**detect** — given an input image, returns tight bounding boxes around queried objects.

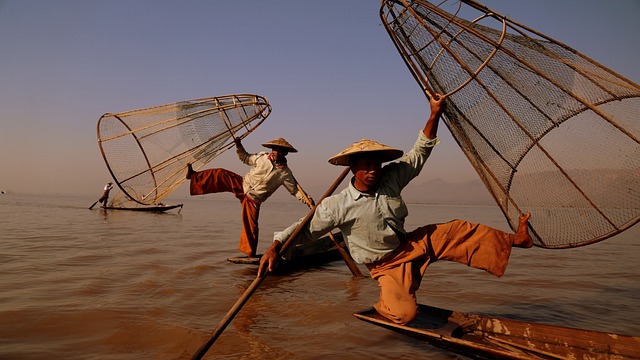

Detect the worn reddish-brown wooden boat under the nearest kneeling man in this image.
[354,305,640,360]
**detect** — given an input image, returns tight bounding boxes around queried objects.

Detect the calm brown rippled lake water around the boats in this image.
[0,194,640,359]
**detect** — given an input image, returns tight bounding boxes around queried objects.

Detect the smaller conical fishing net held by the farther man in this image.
[98,94,271,205]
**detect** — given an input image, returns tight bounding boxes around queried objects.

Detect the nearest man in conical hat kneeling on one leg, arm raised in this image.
[258,95,533,324]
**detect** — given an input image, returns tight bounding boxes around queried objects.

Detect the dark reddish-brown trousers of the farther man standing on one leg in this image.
[189,169,260,256]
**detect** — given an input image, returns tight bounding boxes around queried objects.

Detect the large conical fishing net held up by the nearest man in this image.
[380,0,640,248]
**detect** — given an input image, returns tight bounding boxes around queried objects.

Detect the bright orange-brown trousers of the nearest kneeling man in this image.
[367,220,513,324]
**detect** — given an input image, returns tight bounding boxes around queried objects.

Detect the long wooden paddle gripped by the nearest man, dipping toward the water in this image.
[191,167,349,360]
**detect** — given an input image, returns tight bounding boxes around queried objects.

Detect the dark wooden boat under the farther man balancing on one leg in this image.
[227,233,346,273]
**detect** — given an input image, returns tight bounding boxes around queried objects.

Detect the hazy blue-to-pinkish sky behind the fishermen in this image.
[0,0,640,196]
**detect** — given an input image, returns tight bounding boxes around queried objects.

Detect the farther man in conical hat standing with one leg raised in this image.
[187,138,313,257]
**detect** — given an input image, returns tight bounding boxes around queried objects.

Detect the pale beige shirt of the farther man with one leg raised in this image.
[236,146,309,205]
